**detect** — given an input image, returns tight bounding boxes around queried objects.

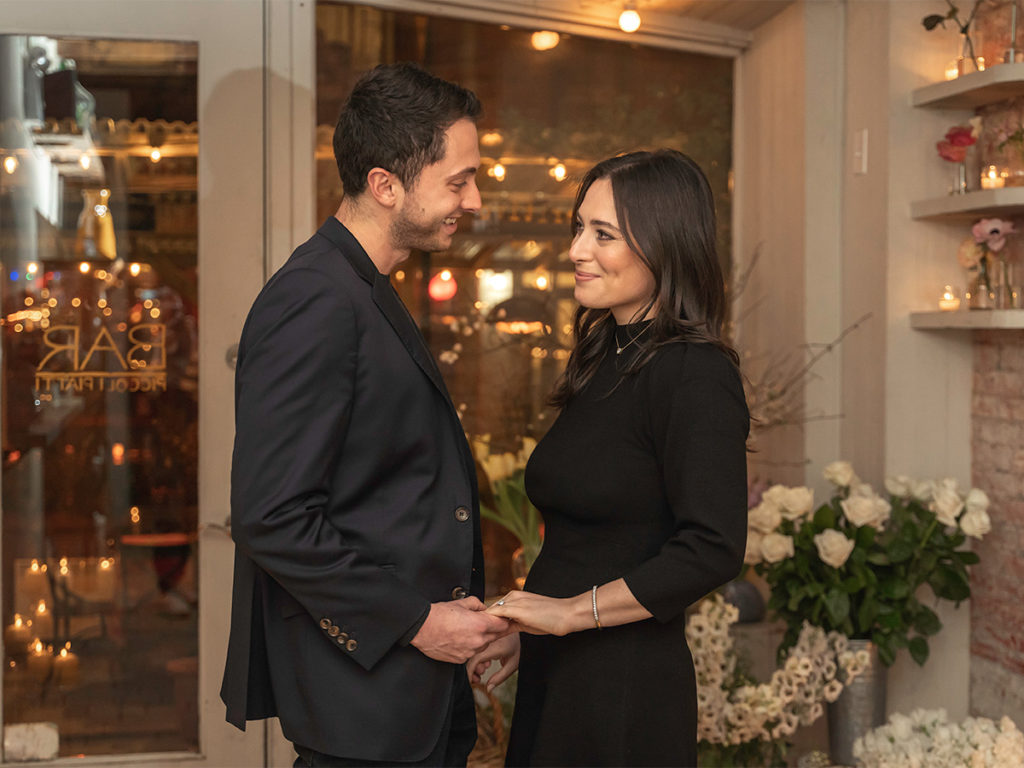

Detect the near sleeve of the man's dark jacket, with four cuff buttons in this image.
[231,268,429,669]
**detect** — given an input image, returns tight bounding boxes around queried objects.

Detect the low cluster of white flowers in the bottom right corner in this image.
[853,710,1024,768]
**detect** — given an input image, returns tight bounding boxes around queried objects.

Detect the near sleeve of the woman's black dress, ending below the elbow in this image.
[626,344,750,622]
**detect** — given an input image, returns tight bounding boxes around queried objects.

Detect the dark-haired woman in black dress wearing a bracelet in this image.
[470,150,750,766]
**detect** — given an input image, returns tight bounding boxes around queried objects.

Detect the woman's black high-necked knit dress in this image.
[506,324,750,766]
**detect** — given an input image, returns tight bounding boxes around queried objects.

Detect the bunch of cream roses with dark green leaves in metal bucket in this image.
[743,461,992,667]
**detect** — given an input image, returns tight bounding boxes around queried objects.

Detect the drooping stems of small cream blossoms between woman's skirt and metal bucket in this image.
[686,595,870,765]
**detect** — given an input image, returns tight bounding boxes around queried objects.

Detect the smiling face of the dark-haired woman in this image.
[569,178,654,325]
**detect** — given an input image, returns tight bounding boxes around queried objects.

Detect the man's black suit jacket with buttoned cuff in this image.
[221,218,483,761]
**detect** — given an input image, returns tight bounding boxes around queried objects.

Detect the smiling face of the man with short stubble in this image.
[391,119,480,252]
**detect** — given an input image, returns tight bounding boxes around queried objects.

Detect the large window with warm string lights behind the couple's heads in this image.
[316,2,732,594]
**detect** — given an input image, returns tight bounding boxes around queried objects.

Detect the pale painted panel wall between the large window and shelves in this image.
[735,0,971,719]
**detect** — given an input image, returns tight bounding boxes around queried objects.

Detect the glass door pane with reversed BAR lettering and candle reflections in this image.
[0,36,199,762]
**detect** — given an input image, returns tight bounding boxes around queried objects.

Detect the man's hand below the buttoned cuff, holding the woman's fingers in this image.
[412,597,511,664]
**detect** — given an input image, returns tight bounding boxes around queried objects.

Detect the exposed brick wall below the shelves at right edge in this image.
[971,331,1024,723]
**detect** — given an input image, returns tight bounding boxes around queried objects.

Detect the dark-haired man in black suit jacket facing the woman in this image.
[221,65,508,766]
